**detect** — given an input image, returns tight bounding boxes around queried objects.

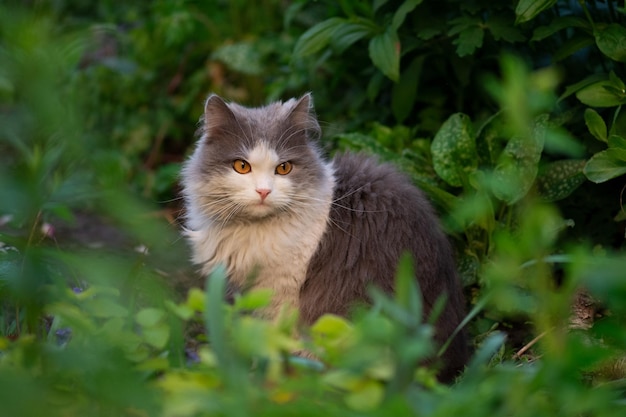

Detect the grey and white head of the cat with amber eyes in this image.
[183,95,332,227]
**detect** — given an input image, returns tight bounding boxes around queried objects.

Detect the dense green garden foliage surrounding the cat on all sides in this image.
[0,0,626,416]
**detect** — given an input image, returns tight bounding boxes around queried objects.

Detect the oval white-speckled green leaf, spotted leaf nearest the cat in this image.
[431,113,478,187]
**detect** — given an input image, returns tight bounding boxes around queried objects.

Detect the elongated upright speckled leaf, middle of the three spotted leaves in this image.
[494,115,548,204]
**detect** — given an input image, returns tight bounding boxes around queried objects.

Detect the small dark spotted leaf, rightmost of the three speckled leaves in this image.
[537,159,586,201]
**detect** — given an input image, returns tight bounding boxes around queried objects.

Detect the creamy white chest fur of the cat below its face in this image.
[187,197,331,316]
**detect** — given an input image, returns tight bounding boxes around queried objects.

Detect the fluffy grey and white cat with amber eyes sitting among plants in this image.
[181,94,468,380]
